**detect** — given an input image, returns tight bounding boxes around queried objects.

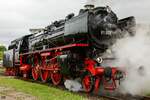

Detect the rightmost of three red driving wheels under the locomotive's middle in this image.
[51,72,62,85]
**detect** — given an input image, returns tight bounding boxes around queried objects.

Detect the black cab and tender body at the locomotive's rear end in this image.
[3,35,29,67]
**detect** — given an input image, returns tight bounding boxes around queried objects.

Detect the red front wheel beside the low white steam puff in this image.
[82,72,95,93]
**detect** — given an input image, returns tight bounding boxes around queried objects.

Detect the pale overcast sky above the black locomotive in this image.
[0,0,150,46]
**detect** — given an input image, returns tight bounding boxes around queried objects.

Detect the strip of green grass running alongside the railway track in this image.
[0,76,86,100]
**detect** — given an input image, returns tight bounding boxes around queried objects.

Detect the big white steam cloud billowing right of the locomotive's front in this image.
[111,26,150,95]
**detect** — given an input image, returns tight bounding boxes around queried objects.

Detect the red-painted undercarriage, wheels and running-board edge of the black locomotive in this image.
[5,44,122,92]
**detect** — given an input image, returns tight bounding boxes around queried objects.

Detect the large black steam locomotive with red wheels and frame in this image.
[3,5,135,92]
